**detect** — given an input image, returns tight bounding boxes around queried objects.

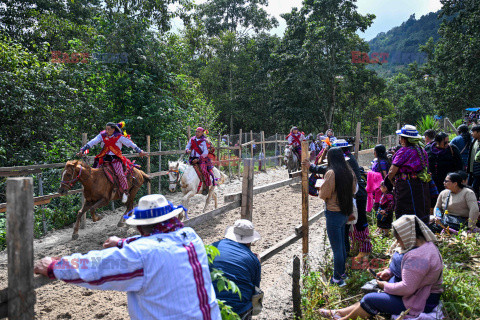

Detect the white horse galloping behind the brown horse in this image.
[168,161,227,212]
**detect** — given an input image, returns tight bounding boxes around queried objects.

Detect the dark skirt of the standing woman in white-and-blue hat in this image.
[394,178,430,223]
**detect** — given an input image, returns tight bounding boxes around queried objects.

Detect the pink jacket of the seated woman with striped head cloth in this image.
[384,242,443,318]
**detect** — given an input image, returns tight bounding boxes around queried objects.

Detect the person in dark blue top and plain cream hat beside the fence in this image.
[210,219,261,320]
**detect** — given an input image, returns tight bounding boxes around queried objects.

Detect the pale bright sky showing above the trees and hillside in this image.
[266,0,442,40]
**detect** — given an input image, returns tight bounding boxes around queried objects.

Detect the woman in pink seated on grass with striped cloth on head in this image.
[319,215,443,320]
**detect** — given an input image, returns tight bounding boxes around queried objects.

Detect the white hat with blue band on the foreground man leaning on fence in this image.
[125,194,187,226]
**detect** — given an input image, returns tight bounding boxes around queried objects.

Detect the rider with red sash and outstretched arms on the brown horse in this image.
[77,121,147,203]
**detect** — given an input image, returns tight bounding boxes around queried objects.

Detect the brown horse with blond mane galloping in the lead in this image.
[58,160,150,240]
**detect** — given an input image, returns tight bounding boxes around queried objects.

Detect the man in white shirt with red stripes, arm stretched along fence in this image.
[35,194,221,320]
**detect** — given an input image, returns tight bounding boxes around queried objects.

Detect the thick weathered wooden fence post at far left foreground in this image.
[7,178,36,320]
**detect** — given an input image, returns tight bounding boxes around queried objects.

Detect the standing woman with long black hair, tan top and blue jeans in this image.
[302,148,357,287]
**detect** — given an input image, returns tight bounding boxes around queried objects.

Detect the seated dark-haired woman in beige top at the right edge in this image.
[435,172,479,231]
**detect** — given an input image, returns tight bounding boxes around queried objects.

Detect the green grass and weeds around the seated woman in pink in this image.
[302,211,480,320]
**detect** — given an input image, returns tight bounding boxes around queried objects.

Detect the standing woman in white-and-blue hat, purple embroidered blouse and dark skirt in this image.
[388,125,430,223]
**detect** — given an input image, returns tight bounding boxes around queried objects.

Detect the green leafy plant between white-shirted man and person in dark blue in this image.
[205,245,242,320]
